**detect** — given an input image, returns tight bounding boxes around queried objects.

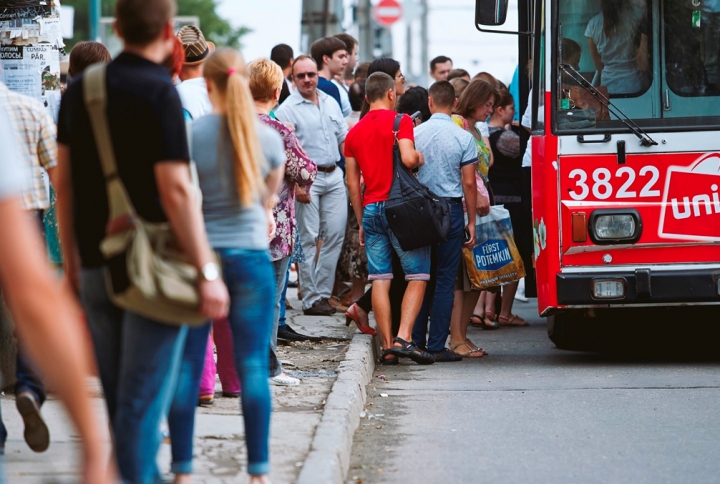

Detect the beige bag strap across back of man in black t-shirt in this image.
[82,63,135,220]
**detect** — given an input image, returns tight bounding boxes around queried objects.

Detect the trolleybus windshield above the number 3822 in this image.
[553,0,720,133]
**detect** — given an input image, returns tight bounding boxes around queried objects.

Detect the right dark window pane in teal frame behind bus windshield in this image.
[664,0,720,99]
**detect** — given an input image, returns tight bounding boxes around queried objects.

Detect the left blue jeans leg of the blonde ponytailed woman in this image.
[168,322,210,474]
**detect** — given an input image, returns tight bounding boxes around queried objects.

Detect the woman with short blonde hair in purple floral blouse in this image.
[248,59,317,386]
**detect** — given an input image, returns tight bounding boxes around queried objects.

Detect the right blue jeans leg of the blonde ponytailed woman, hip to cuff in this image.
[216,249,275,475]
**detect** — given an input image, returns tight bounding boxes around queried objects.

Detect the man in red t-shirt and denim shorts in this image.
[345,72,435,365]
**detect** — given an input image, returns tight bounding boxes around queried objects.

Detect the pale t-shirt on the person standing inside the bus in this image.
[585,8,647,94]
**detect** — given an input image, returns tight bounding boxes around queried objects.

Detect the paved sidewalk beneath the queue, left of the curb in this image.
[0,289,355,484]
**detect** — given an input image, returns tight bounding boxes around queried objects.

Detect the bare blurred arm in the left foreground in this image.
[0,198,111,484]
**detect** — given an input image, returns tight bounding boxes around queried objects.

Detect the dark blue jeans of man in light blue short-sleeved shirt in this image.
[412,200,465,351]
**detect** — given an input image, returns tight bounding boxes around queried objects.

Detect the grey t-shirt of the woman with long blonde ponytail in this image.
[192,114,285,250]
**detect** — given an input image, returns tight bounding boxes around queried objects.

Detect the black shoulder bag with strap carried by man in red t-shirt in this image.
[385,114,450,250]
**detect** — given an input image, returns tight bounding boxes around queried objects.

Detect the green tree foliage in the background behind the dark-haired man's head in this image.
[61,0,252,52]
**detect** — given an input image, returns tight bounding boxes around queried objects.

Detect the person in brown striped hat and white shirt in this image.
[177,25,215,120]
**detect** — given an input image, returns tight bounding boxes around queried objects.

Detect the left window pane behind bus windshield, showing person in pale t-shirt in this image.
[557,0,652,97]
